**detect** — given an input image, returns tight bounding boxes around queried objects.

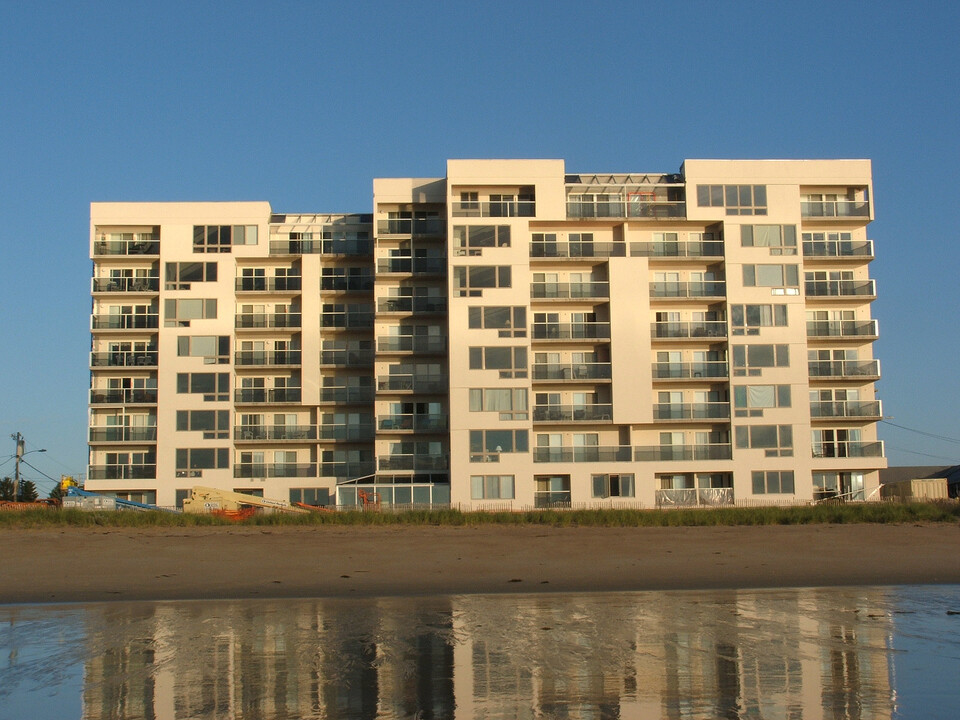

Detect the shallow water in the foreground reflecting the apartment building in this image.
[0,586,960,720]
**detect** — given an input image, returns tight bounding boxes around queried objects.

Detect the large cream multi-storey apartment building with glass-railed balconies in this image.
[86,160,886,509]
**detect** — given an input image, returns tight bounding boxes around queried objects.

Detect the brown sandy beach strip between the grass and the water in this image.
[0,524,960,603]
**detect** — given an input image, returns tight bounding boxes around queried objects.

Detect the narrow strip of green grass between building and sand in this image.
[0,501,960,530]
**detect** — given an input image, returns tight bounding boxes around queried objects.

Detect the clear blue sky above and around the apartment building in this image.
[0,0,960,487]
